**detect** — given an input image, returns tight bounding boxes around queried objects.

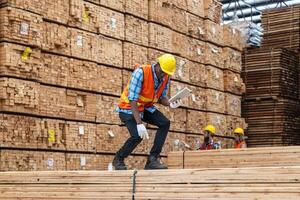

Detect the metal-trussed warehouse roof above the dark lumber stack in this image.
[221,0,300,24]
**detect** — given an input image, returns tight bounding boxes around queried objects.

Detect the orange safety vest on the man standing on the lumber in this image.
[119,65,169,112]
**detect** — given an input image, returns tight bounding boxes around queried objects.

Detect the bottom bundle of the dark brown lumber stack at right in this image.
[242,98,300,146]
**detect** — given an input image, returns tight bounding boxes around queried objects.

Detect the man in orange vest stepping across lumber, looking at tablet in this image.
[112,54,181,170]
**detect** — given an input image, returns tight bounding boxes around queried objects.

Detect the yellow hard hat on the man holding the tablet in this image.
[157,54,176,76]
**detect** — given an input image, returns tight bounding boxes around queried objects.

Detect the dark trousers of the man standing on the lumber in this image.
[116,110,170,158]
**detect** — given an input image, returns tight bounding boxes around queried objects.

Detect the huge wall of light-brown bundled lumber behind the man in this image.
[0,0,245,170]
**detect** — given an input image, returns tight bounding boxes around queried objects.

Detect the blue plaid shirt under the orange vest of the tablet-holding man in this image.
[117,65,170,114]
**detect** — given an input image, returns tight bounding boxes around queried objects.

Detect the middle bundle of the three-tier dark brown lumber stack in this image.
[242,49,299,100]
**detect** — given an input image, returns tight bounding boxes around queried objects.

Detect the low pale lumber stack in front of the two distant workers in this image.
[168,146,300,169]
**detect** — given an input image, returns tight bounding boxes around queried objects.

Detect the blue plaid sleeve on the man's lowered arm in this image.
[128,68,144,101]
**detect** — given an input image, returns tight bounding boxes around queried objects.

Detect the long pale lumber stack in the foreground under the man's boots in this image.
[0,166,300,200]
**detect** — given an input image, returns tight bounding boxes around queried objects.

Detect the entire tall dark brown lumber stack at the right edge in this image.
[242,5,300,147]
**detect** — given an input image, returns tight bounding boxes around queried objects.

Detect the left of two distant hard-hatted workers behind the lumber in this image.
[199,124,220,150]
